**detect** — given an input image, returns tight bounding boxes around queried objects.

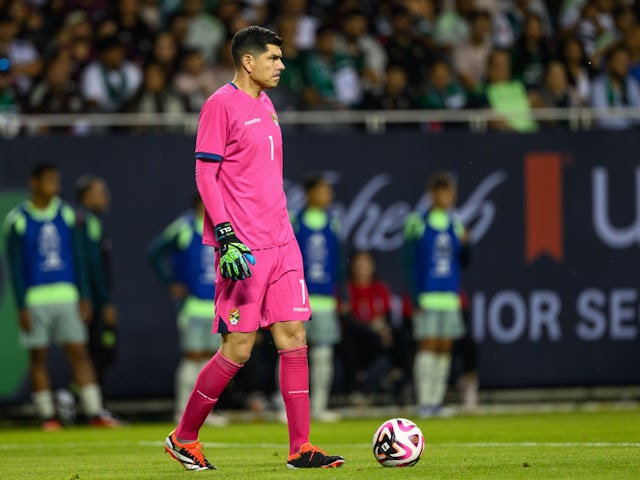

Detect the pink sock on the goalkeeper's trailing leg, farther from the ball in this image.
[176,350,242,441]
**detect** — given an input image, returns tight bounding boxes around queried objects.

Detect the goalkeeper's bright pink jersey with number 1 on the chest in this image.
[196,83,295,249]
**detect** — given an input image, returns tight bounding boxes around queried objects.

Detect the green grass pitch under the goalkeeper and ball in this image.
[0,410,640,480]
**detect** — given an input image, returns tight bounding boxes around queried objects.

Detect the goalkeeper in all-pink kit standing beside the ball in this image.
[165,26,344,470]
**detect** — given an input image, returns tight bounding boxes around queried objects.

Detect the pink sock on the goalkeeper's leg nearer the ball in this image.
[278,346,310,455]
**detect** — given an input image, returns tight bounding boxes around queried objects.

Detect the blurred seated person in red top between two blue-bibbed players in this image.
[343,251,393,401]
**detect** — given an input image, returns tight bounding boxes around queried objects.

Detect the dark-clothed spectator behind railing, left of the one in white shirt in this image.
[28,52,86,133]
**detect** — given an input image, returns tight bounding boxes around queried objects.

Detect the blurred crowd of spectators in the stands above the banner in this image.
[0,0,640,132]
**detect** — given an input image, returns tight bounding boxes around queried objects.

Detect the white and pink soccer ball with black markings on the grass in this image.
[373,418,424,467]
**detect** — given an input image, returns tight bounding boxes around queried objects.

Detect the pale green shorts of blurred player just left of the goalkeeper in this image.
[178,297,222,353]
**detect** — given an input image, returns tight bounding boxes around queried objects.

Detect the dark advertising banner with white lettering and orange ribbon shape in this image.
[0,130,640,399]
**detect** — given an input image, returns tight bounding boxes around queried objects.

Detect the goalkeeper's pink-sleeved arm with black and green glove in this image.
[196,101,256,280]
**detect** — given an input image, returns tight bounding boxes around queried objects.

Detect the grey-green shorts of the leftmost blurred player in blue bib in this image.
[20,302,87,349]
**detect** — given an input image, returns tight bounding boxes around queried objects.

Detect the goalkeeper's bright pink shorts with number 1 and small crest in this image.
[212,239,311,333]
